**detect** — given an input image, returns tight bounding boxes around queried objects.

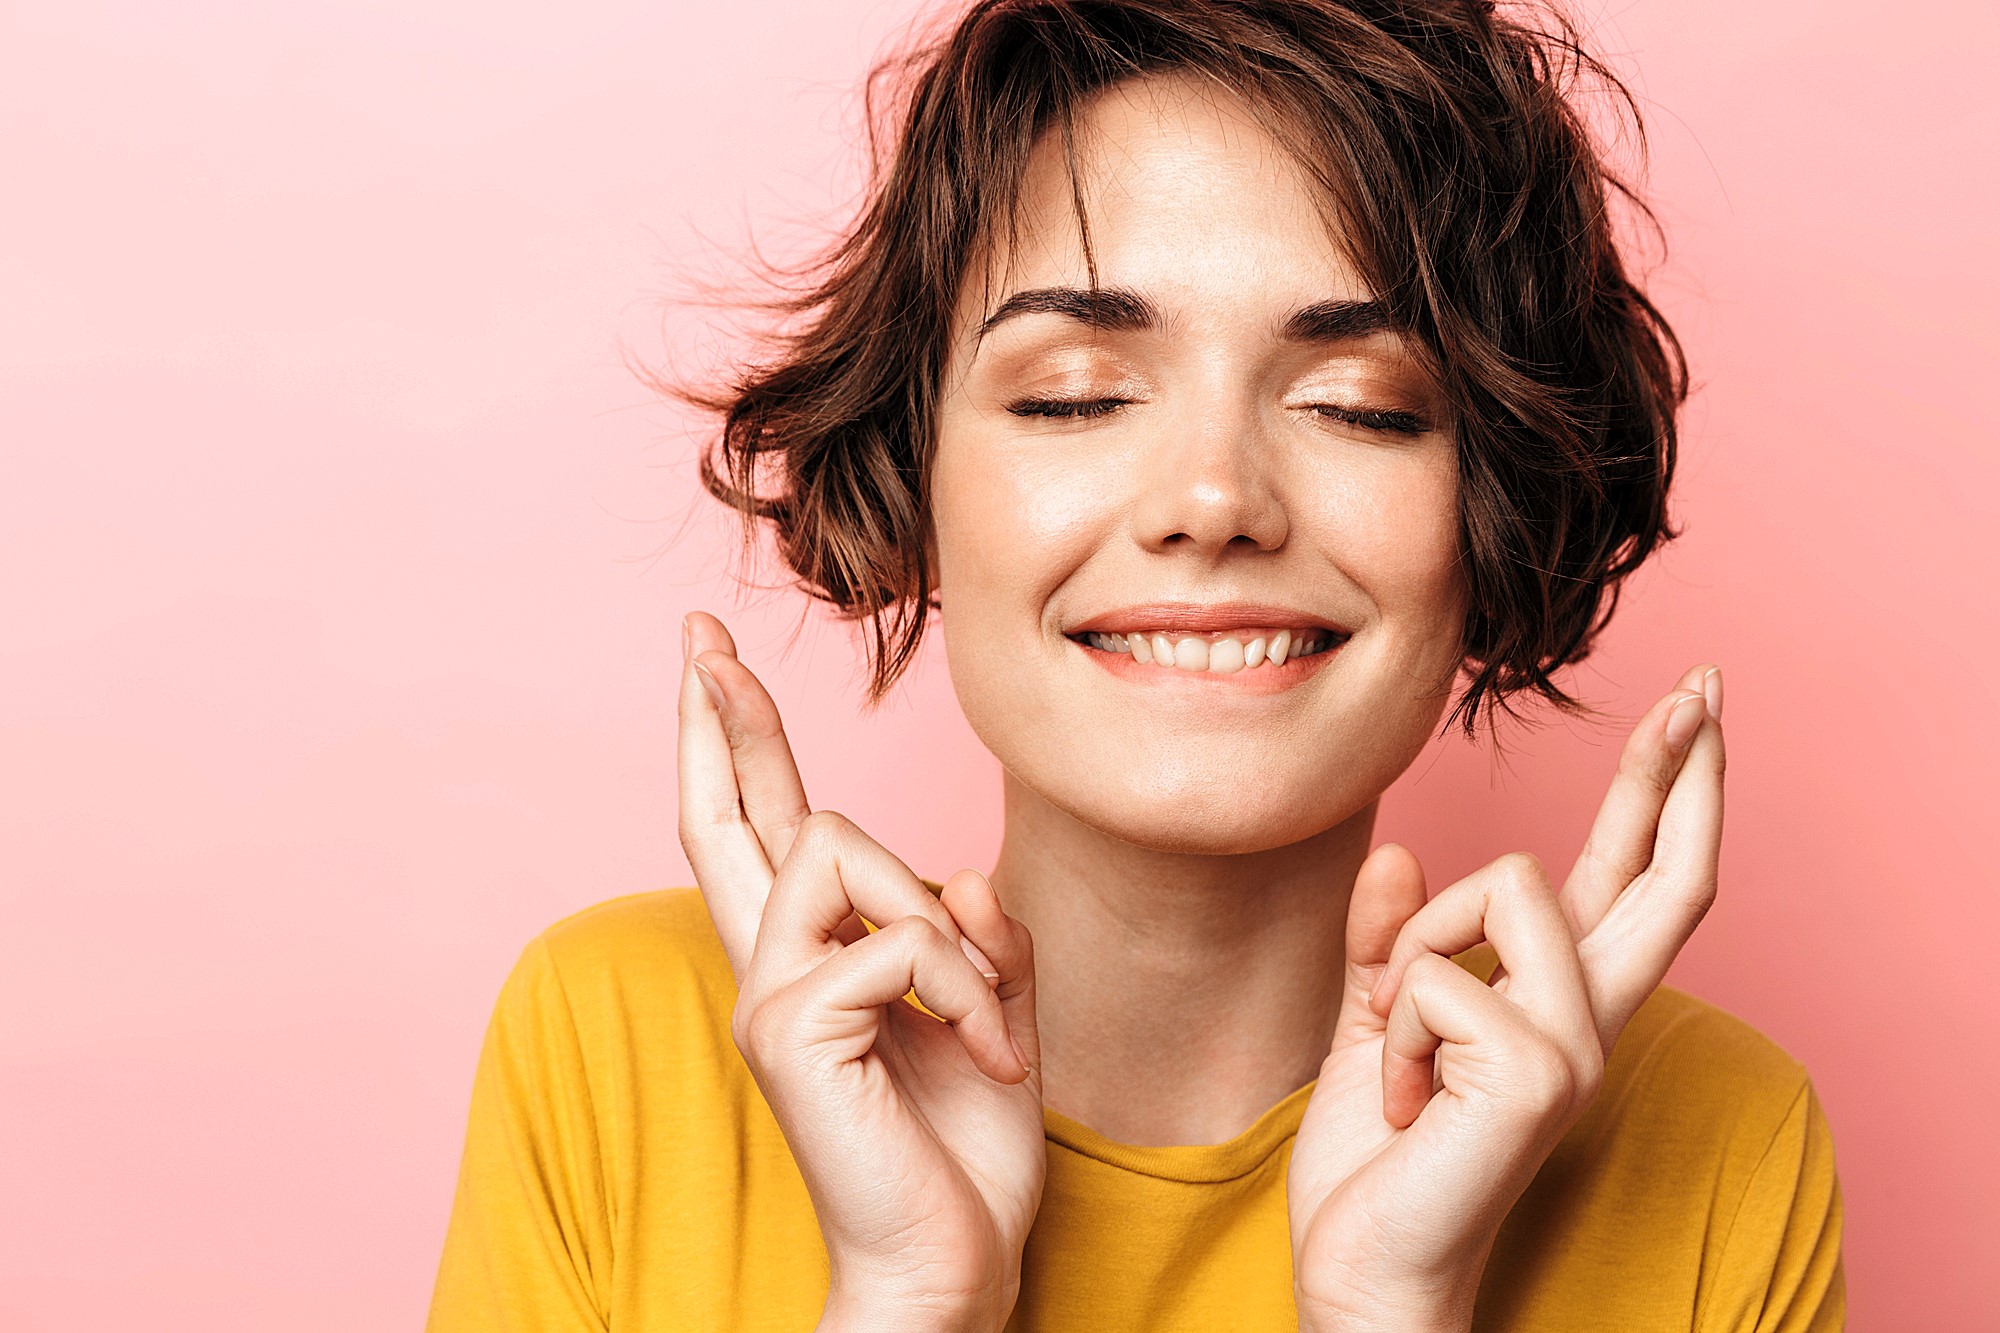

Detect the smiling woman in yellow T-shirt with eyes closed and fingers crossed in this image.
[432,0,1844,1331]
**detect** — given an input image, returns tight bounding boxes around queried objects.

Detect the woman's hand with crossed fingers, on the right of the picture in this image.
[1286,664,1724,1333]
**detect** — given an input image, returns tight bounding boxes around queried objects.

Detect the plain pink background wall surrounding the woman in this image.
[0,0,2000,1333]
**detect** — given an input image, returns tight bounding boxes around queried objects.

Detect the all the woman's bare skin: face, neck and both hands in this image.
[680,78,1724,1333]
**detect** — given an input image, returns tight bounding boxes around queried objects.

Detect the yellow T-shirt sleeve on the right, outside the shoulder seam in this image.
[1700,1079,1848,1333]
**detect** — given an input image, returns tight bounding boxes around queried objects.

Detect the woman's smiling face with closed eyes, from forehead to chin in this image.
[932,76,1466,853]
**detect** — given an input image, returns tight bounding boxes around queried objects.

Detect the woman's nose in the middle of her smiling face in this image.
[1134,392,1290,554]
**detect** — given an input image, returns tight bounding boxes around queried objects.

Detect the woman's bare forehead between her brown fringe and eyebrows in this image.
[956,74,1372,332]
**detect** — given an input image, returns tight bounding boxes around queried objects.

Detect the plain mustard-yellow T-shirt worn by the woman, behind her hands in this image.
[430,887,1846,1333]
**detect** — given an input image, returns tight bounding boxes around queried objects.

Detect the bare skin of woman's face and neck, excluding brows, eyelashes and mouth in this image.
[932,80,1466,1143]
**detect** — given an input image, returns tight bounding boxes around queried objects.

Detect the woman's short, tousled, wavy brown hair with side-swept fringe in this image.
[662,0,1688,737]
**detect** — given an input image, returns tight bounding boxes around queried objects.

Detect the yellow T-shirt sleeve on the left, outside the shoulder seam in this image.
[426,939,610,1333]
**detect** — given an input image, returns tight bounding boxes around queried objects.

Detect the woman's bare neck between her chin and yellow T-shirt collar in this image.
[992,775,1376,1145]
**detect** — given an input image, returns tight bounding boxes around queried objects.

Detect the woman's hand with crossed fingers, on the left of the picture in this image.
[680,612,1046,1329]
